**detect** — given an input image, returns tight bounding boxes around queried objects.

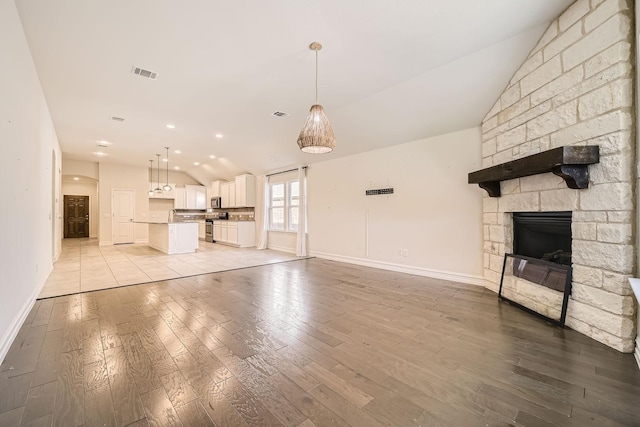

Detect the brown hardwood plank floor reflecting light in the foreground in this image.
[0,259,640,427]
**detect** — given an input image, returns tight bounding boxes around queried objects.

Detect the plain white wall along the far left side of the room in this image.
[0,0,62,360]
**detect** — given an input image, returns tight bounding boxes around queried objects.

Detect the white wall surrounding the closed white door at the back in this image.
[98,163,149,245]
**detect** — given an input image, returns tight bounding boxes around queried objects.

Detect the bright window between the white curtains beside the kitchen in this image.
[269,180,300,232]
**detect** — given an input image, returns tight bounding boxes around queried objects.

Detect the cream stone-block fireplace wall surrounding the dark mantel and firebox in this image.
[479,0,636,352]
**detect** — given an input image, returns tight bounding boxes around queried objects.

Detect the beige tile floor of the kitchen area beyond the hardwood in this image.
[38,238,299,298]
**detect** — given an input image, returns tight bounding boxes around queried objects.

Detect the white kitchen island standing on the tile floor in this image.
[148,221,198,255]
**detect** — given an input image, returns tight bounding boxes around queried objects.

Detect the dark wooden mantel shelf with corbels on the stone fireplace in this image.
[469,145,600,197]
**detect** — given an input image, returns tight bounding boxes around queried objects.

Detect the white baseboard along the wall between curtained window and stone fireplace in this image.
[309,252,484,286]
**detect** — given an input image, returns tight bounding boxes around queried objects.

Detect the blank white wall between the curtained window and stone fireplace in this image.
[307,128,483,284]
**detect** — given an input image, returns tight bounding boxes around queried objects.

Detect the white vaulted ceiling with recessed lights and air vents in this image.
[15,0,572,182]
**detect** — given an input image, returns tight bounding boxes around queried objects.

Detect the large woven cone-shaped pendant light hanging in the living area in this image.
[298,42,336,154]
